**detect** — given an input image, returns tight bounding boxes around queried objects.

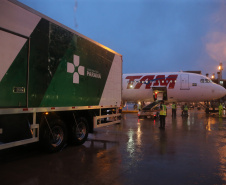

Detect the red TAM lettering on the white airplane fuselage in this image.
[125,75,178,89]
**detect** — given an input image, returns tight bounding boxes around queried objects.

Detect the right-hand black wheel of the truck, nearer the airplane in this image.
[70,117,89,145]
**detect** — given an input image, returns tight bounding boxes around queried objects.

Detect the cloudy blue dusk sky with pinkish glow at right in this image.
[19,0,226,78]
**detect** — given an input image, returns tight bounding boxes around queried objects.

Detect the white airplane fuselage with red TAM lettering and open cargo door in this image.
[122,72,226,102]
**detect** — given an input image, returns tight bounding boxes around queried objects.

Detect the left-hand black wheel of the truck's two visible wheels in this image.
[40,119,67,152]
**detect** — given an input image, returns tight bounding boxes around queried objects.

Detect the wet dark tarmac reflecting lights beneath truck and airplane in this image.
[0,109,226,185]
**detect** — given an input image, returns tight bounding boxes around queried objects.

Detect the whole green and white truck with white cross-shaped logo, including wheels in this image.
[0,0,122,152]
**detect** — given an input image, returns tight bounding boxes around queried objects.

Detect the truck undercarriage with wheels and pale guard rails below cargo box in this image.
[0,106,121,152]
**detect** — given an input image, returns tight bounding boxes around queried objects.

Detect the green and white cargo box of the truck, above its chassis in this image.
[0,0,121,107]
